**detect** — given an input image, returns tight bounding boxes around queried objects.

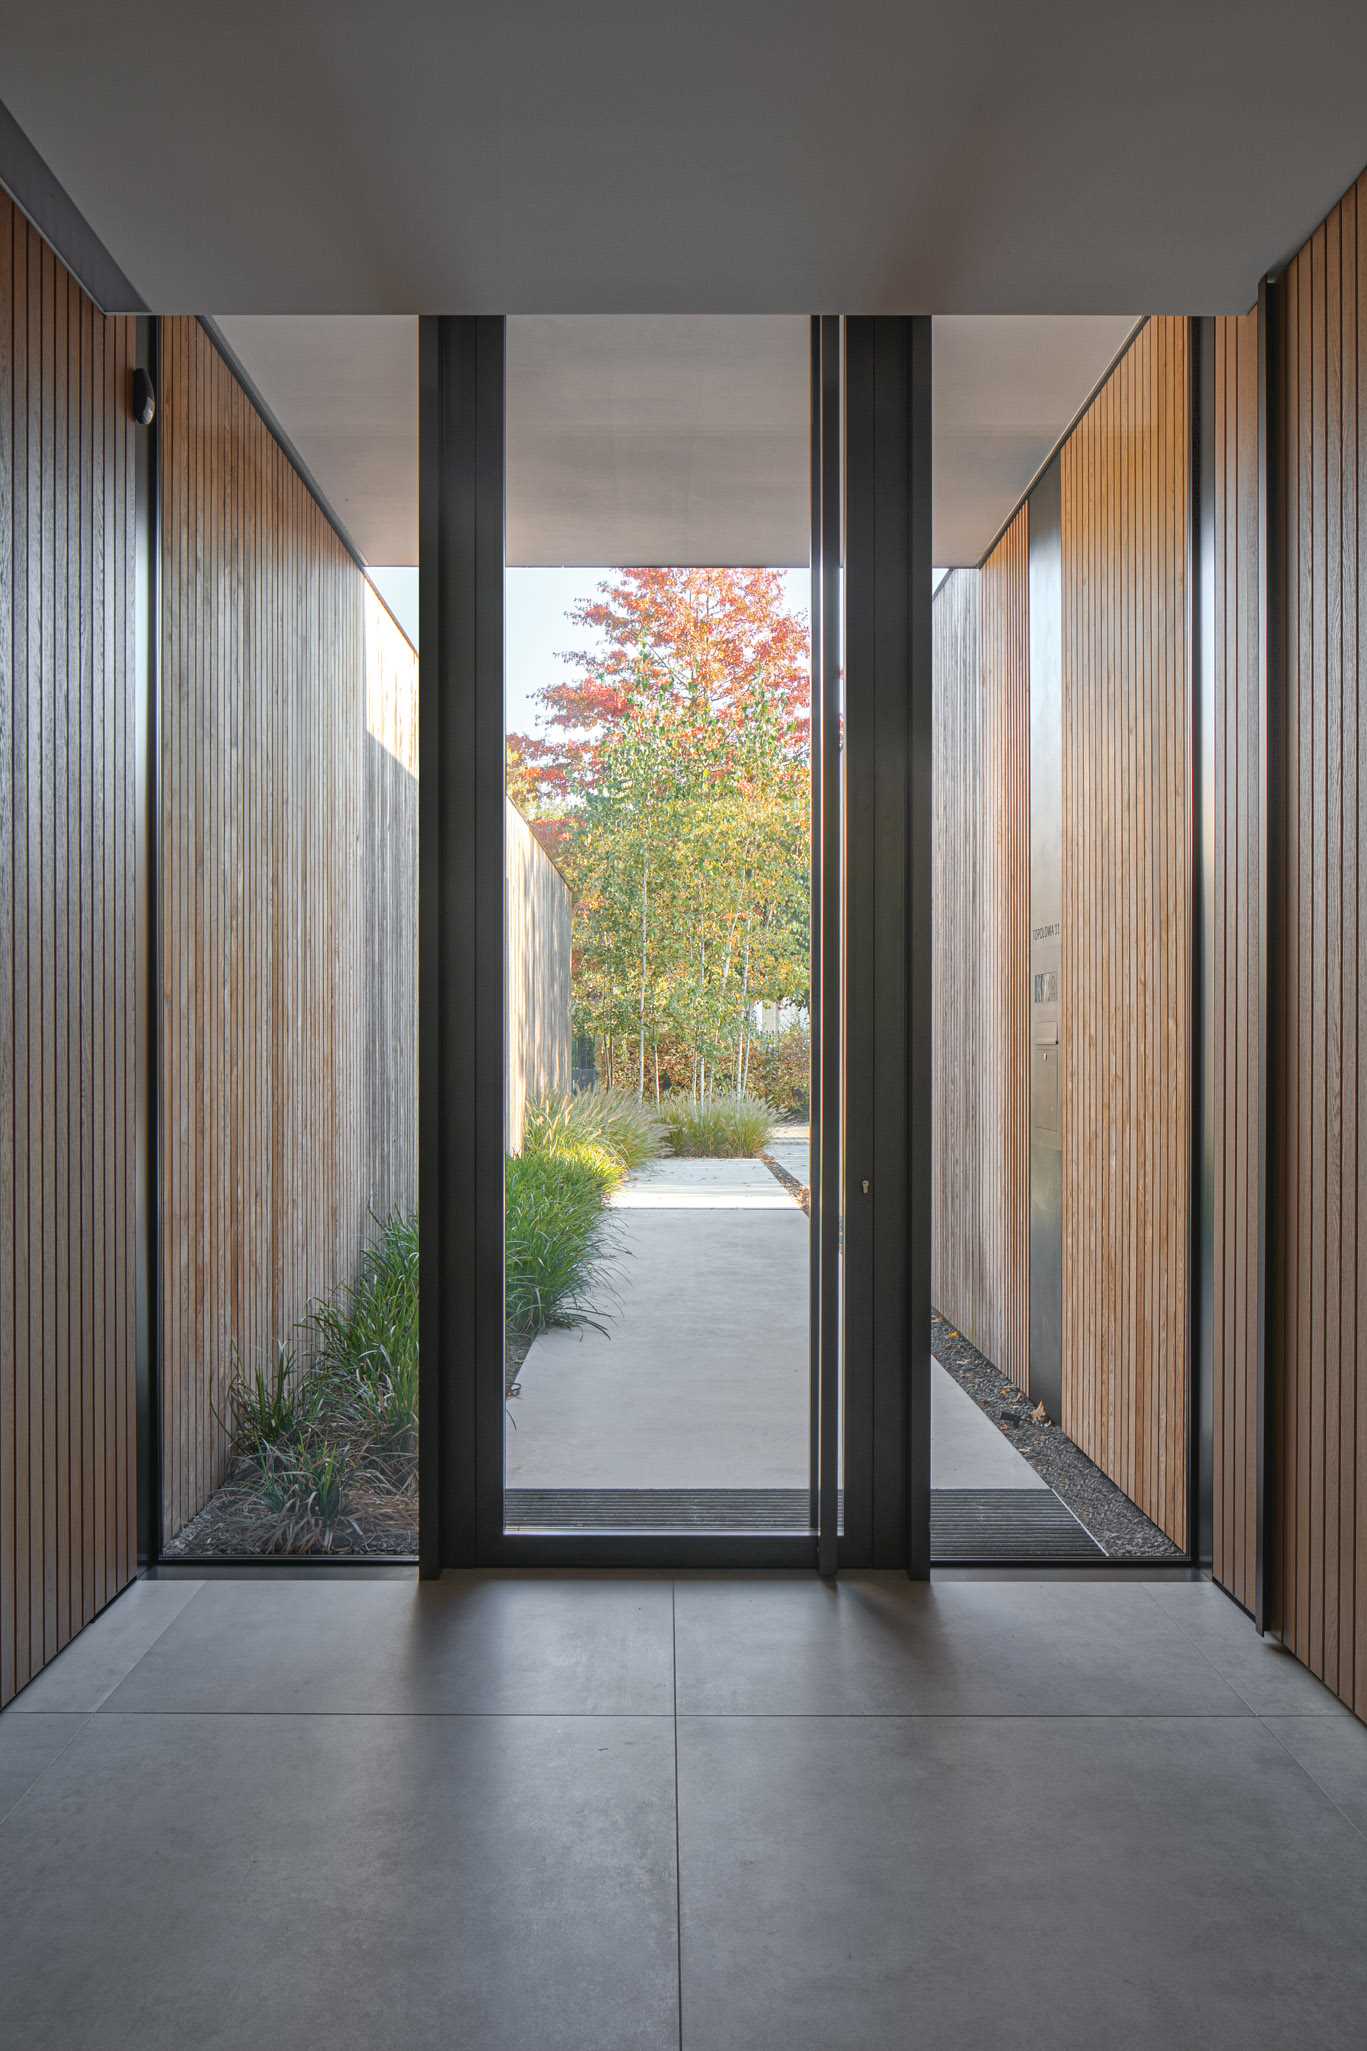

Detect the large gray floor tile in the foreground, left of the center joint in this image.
[0,1713,678,2051]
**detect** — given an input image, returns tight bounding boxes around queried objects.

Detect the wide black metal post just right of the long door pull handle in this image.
[844,316,930,1577]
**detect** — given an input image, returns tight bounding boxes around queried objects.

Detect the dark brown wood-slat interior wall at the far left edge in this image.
[0,193,137,1702]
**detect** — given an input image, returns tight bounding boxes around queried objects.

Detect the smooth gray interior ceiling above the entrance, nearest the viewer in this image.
[0,0,1367,314]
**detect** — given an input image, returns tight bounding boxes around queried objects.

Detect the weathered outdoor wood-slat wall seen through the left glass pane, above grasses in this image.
[160,320,416,1538]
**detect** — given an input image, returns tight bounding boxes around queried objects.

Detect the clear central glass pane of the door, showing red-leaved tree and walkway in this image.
[500,318,822,1557]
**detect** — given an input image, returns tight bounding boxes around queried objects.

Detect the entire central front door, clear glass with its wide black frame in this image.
[418,316,930,1573]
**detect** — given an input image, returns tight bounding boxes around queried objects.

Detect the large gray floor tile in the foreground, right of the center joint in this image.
[678,1717,1367,2051]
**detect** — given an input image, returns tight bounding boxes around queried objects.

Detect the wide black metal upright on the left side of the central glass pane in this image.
[418,316,504,1575]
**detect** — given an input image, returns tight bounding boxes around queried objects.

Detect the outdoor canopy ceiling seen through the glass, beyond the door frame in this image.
[219,316,1133,566]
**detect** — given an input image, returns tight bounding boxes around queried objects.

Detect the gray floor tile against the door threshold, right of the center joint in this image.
[676,1573,1246,1717]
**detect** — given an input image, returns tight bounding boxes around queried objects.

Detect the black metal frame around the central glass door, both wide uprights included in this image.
[418,316,930,1575]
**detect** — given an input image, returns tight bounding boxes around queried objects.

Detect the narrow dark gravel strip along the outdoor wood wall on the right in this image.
[930,1311,1183,1559]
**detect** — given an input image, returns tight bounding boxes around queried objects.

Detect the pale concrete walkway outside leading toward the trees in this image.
[506,1136,1045,1489]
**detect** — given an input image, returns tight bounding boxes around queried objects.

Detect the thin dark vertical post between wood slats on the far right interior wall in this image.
[1254,277,1287,1631]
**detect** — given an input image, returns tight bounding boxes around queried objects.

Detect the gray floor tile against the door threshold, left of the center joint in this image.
[107,1573,674,1717]
